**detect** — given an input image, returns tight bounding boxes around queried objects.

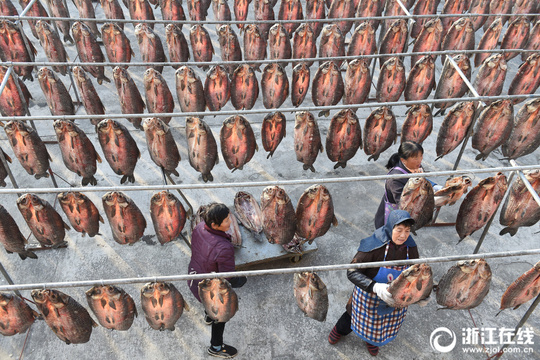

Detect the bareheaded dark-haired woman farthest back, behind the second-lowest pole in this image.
[375,141,424,229]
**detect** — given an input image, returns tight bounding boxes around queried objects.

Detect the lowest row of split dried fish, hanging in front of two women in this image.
[0,259,540,344]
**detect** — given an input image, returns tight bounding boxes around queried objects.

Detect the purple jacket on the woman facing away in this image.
[188,221,234,302]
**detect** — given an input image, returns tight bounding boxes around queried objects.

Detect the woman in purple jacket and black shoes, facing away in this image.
[188,203,247,359]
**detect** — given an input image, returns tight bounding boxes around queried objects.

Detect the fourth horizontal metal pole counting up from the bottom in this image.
[5,49,540,67]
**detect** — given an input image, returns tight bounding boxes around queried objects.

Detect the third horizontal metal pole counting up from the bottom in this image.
[1,94,540,121]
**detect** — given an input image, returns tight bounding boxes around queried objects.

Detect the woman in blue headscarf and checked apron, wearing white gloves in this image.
[328,210,427,356]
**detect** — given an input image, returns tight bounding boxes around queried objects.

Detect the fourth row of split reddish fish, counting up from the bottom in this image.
[4,36,540,122]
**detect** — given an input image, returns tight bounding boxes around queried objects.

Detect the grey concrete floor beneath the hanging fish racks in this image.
[0,2,540,360]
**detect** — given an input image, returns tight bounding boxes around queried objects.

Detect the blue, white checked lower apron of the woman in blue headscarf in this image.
[351,286,407,346]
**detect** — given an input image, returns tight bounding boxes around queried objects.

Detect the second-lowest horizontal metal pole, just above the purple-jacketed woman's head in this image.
[0,164,540,194]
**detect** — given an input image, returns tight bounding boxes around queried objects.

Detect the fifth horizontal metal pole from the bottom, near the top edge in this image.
[0,12,535,25]
